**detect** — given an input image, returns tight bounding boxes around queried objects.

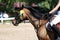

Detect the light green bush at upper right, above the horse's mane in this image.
[38,0,58,10]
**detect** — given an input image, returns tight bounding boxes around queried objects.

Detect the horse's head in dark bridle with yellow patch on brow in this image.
[12,6,26,26]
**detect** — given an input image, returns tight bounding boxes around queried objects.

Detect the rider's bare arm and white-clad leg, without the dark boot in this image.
[49,0,60,26]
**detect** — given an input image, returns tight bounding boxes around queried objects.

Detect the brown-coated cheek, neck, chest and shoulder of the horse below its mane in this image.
[14,8,54,40]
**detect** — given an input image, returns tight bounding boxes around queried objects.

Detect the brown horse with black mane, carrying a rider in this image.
[12,7,54,40]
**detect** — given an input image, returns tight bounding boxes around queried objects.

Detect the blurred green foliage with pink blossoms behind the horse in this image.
[0,0,58,17]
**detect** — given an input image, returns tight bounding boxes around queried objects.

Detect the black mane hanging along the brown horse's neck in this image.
[25,6,48,19]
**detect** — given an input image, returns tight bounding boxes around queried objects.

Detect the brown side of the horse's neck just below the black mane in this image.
[23,8,39,28]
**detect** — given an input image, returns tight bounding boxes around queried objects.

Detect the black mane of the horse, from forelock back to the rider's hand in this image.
[18,6,52,19]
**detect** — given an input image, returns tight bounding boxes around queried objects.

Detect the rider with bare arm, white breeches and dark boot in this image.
[49,0,60,36]
